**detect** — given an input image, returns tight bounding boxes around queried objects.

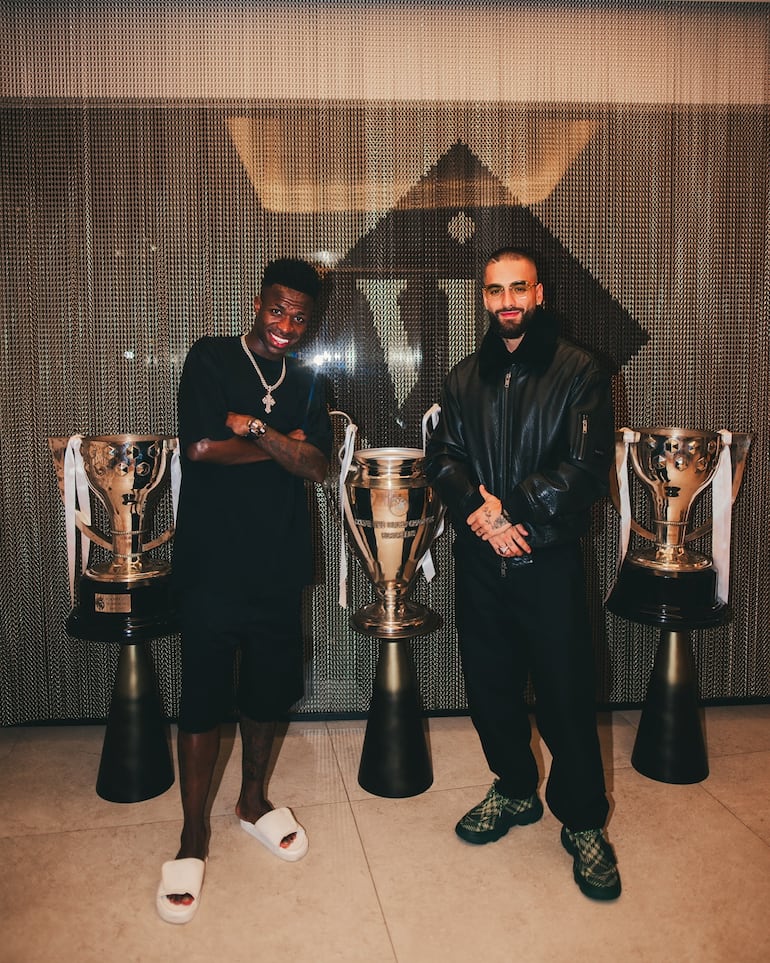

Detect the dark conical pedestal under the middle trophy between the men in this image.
[358,639,433,799]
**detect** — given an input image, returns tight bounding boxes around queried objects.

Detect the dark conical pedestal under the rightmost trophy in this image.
[631,629,709,784]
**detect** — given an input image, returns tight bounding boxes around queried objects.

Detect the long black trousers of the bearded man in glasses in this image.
[455,544,609,831]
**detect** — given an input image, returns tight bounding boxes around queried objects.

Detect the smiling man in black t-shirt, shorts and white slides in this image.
[156,259,332,923]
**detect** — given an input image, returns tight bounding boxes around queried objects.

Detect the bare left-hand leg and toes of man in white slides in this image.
[168,726,219,905]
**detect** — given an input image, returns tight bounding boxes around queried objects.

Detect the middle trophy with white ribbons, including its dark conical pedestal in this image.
[338,405,444,797]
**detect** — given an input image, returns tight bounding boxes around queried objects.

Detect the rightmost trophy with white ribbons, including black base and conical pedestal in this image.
[607,427,751,783]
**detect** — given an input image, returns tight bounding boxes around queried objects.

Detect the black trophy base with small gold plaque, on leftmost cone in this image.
[67,574,176,642]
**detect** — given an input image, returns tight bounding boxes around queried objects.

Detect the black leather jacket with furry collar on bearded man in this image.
[426,308,614,558]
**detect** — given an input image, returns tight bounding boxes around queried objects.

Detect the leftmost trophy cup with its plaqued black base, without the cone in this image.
[49,434,177,641]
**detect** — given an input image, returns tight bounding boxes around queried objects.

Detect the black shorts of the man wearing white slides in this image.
[177,589,304,732]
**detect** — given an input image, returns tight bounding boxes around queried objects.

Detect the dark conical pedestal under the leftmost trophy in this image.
[96,642,174,802]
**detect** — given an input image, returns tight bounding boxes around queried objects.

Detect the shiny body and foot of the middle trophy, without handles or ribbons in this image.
[343,448,443,639]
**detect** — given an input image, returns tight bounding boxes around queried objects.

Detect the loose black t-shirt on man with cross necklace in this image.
[173,337,332,601]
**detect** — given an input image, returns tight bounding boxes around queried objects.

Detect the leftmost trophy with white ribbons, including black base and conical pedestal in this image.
[48,435,179,802]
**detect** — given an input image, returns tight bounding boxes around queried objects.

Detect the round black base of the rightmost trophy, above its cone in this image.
[607,558,727,631]
